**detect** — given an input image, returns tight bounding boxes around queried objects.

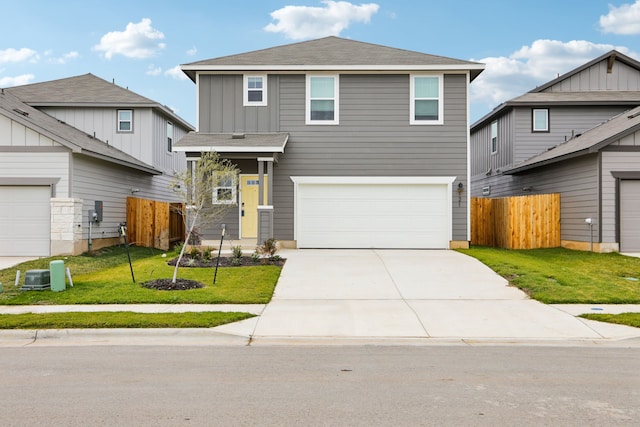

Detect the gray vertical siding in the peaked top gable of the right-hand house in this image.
[545,60,640,92]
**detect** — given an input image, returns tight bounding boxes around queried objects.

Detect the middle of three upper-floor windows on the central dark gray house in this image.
[306,75,339,125]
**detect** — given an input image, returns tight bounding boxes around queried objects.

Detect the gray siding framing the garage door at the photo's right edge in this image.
[602,150,640,242]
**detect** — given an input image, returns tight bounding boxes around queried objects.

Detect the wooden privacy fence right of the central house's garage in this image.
[471,194,560,249]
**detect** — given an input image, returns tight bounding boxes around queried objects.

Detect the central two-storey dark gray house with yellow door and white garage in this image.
[174,37,484,248]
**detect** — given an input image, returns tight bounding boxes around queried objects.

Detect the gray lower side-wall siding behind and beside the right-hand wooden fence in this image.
[472,154,608,242]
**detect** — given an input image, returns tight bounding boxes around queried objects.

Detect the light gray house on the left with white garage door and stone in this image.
[0,74,193,256]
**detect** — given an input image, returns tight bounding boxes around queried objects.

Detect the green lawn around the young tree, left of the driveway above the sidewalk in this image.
[0,247,281,305]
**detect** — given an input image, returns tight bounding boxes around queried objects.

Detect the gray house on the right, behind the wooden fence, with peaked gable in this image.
[471,51,640,252]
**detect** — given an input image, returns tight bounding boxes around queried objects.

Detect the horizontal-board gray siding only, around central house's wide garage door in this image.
[274,75,467,240]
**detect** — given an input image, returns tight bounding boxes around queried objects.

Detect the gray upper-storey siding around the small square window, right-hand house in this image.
[514,106,628,164]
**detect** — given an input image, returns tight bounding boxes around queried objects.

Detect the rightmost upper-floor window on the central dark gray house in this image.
[410,75,443,125]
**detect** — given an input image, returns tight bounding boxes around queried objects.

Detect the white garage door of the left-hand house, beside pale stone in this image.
[0,186,51,256]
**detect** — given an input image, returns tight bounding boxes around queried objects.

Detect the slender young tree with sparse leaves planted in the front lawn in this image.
[171,152,238,283]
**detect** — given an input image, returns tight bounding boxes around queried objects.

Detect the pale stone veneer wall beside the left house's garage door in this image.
[51,198,84,256]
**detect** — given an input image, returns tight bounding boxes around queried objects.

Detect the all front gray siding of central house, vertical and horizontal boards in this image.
[199,74,468,244]
